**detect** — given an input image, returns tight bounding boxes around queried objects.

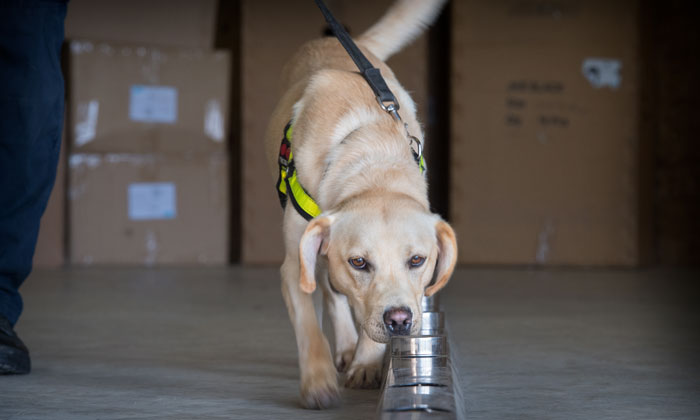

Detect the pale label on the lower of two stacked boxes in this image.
[128,182,177,220]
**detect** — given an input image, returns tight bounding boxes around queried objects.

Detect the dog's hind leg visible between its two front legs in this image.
[317,268,357,372]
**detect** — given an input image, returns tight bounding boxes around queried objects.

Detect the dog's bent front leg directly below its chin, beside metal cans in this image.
[345,329,386,388]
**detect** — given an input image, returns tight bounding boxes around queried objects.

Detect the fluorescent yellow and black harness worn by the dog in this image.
[277,121,425,220]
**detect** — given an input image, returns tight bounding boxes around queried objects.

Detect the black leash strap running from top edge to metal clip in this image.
[315,0,401,120]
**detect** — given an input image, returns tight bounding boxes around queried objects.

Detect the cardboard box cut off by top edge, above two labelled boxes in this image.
[66,0,218,49]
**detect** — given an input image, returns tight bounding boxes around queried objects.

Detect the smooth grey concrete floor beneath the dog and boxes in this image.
[0,267,700,420]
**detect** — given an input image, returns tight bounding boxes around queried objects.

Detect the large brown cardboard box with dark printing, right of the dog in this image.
[450,0,639,265]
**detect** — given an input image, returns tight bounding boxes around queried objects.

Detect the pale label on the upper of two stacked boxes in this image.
[129,85,177,124]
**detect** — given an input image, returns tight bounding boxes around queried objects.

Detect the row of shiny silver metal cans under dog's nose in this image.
[378,296,461,420]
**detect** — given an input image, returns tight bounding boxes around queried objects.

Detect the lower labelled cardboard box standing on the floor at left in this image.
[69,153,229,266]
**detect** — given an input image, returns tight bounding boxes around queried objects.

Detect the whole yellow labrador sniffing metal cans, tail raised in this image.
[266,0,457,408]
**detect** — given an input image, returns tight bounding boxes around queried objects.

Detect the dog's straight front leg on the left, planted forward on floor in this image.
[280,206,340,408]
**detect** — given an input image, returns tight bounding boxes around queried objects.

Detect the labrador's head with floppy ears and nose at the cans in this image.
[299,194,457,342]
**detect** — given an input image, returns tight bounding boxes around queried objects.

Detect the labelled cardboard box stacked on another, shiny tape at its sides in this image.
[68,41,230,153]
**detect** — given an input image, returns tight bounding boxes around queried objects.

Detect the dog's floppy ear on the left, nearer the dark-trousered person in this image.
[299,216,333,293]
